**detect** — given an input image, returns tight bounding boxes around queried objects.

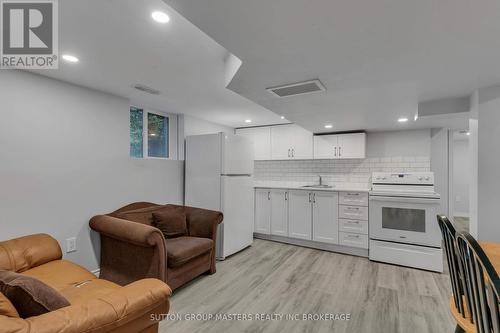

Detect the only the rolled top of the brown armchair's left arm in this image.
[90,215,164,247]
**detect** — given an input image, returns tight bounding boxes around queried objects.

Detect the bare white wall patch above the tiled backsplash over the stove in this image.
[366,129,431,157]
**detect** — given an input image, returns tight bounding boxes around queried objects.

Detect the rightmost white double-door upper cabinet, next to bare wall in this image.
[314,133,366,159]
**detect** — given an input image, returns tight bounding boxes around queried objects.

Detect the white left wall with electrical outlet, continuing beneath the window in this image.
[0,70,183,270]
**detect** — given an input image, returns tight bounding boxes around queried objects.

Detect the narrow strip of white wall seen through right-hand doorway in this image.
[452,139,471,216]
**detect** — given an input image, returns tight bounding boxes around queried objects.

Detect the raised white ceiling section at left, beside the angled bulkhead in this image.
[31,0,283,127]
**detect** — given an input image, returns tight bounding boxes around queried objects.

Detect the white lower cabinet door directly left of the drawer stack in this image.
[312,192,339,244]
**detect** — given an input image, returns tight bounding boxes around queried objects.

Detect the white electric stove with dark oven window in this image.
[369,172,443,272]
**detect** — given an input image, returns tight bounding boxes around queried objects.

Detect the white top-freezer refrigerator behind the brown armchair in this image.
[185,133,254,260]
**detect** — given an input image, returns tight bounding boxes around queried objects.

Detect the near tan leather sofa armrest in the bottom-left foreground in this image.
[0,279,172,333]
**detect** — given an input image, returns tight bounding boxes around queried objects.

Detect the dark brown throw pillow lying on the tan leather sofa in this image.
[0,271,70,318]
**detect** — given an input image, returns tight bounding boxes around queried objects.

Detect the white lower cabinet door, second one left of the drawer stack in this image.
[288,190,312,240]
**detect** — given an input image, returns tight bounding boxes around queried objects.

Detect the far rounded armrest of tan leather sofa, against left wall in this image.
[0,234,62,272]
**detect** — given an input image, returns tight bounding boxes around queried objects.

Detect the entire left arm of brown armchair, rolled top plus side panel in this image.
[90,215,167,286]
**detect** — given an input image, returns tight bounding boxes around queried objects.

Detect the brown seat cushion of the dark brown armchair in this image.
[166,236,214,268]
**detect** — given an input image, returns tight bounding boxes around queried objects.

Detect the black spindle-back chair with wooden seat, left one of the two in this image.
[437,215,476,333]
